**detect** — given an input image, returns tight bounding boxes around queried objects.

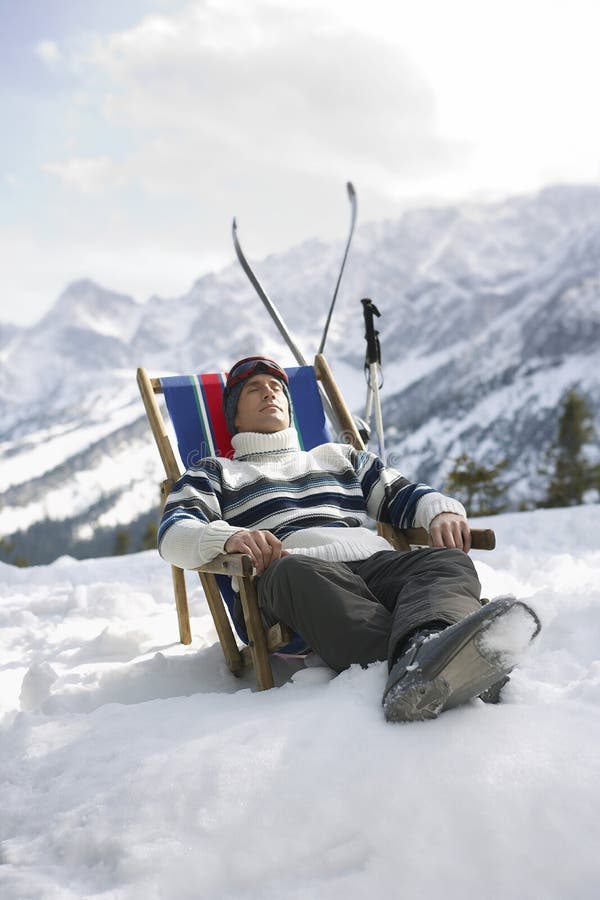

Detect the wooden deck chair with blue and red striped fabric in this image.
[137,354,495,690]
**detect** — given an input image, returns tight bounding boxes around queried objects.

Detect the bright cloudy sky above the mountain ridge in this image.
[0,0,600,325]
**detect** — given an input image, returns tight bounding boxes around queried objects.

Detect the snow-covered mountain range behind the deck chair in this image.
[0,186,600,562]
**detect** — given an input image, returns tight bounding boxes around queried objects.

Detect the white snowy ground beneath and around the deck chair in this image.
[0,505,600,900]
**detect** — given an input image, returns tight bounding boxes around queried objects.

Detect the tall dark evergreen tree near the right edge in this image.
[544,387,600,506]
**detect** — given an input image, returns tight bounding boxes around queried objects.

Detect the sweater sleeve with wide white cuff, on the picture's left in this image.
[158,465,240,569]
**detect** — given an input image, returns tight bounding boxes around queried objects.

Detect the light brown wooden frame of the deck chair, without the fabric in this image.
[137,354,495,690]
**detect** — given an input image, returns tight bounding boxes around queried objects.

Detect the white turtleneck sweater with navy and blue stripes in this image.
[158,428,465,569]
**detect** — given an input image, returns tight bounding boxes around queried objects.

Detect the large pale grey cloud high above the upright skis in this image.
[78,0,464,193]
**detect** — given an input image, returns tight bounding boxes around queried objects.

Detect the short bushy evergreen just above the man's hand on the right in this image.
[446,453,508,516]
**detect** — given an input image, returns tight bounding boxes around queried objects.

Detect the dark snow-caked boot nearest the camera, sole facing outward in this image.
[382,597,541,722]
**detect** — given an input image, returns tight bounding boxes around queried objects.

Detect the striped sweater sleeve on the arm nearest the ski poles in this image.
[352,450,466,530]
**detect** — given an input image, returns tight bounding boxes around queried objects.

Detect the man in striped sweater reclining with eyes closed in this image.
[158,357,540,721]
